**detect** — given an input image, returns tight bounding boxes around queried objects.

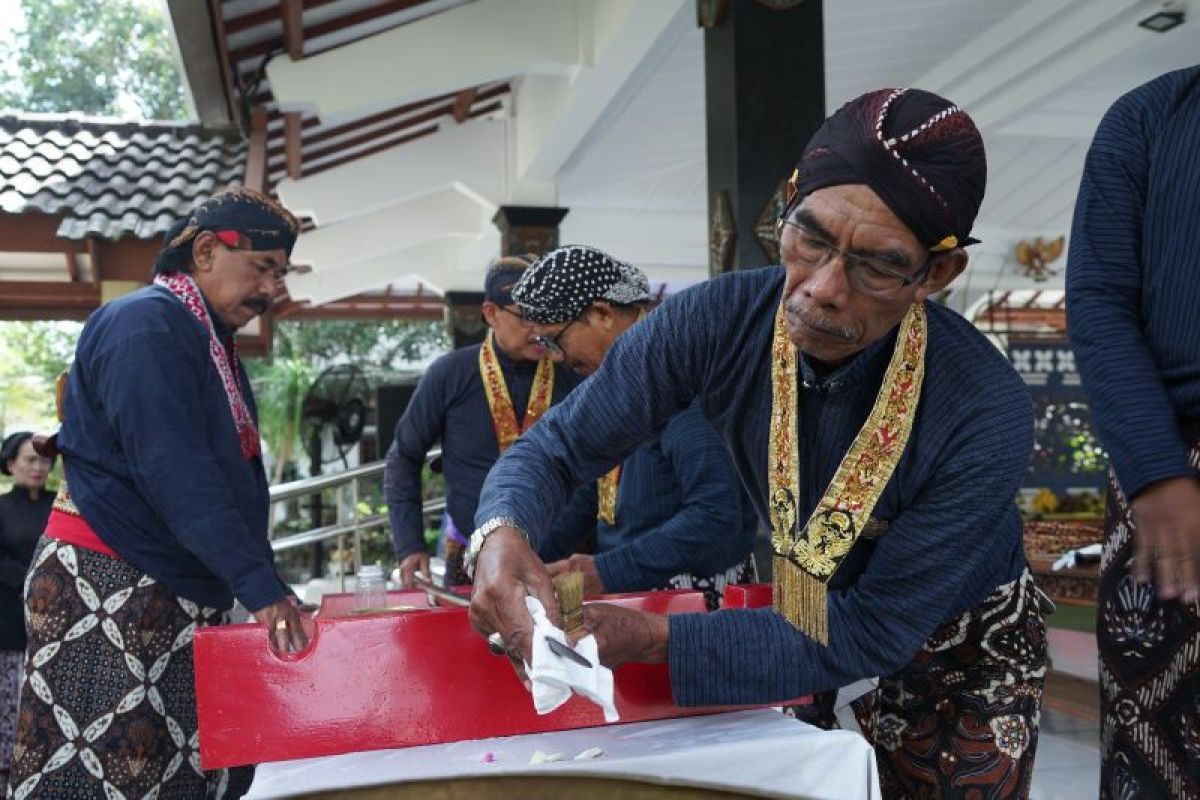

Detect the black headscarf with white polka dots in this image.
[512,245,650,325]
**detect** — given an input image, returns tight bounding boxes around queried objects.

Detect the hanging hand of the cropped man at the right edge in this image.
[1132,477,1200,603]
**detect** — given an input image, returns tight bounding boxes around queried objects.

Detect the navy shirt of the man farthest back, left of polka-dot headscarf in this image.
[384,344,585,558]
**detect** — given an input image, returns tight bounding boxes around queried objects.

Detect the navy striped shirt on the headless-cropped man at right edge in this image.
[1067,67,1200,497]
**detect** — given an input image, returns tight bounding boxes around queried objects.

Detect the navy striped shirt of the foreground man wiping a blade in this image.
[475,267,1033,705]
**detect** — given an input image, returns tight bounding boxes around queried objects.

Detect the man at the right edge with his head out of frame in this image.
[1067,67,1200,798]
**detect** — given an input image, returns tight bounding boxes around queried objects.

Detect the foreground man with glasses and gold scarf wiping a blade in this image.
[472,90,1045,798]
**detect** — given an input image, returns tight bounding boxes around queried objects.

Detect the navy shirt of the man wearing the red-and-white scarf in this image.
[59,287,289,610]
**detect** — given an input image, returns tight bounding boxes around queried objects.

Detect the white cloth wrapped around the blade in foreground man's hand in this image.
[526,597,620,722]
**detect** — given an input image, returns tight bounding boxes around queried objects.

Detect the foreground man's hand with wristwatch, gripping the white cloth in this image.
[470,527,563,688]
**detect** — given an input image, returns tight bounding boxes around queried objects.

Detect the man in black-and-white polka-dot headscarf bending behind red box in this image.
[512,245,757,608]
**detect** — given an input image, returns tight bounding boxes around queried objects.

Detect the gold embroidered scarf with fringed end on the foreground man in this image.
[767,303,926,644]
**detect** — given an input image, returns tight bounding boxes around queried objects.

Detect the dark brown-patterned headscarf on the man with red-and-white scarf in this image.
[154,186,300,275]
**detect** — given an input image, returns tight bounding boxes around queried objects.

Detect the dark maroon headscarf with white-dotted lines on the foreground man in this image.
[788,89,988,252]
